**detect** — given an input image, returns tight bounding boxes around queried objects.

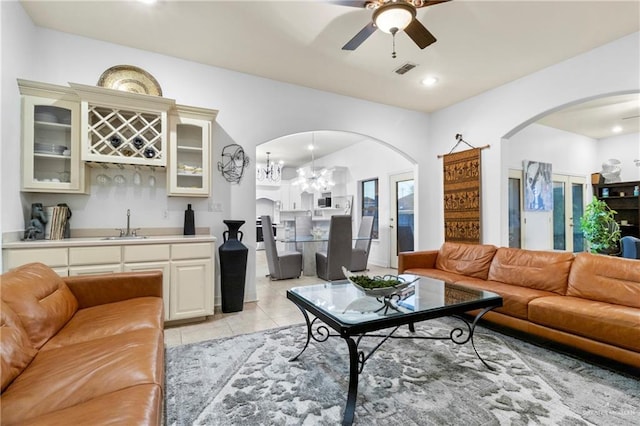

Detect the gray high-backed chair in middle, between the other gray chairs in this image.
[316,215,351,281]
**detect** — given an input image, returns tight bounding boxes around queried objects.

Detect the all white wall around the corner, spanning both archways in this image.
[0,2,640,299]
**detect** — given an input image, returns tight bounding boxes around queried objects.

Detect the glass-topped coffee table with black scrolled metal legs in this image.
[287,275,502,425]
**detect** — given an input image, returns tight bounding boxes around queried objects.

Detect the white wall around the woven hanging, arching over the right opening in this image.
[428,33,640,248]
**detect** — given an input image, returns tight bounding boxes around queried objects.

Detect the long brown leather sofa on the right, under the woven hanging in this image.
[398,242,640,368]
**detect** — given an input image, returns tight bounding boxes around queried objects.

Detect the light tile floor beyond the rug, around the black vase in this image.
[164,250,398,346]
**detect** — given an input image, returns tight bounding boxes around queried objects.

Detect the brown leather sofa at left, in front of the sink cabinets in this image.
[0,263,164,426]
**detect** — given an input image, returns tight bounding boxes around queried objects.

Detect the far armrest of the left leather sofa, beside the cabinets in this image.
[63,271,162,309]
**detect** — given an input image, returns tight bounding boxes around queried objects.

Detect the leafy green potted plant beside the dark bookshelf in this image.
[580,197,620,254]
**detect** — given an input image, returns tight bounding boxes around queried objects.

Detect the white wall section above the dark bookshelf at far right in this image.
[594,133,640,182]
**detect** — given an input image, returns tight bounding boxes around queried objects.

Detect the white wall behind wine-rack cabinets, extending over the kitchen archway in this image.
[0,2,429,301]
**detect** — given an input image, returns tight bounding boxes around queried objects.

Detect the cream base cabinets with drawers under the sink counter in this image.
[2,236,215,321]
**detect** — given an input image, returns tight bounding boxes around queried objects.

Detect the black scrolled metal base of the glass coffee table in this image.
[289,304,495,425]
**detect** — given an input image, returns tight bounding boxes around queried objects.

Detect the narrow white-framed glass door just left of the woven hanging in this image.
[389,173,415,268]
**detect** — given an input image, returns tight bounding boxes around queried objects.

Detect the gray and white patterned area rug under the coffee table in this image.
[165,318,640,426]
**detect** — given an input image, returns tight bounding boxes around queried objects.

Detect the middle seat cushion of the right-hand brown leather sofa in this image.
[456,278,555,320]
